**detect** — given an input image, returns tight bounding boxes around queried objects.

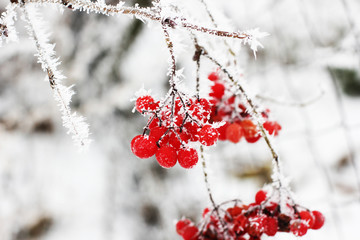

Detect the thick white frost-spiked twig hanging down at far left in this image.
[21,5,91,149]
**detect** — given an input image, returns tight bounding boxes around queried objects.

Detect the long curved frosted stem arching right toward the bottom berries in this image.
[204,52,284,188]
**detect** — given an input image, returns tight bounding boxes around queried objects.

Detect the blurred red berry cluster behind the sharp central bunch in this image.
[208,72,281,143]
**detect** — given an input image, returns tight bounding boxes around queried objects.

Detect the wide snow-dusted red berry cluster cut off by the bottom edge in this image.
[176,190,325,240]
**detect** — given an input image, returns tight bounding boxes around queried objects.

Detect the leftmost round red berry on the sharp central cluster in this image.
[131,135,158,158]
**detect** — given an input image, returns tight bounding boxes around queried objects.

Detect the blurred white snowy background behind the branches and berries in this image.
[0,0,360,240]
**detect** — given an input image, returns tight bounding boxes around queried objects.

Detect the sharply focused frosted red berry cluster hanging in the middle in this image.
[131,92,219,168]
